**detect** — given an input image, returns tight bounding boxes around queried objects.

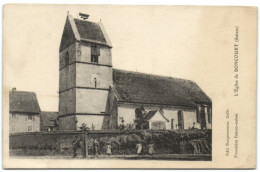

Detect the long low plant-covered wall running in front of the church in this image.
[9,130,211,156]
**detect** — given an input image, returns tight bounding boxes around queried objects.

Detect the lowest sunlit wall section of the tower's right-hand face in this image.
[76,115,108,130]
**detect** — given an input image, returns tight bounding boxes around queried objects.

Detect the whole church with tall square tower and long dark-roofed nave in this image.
[58,13,212,130]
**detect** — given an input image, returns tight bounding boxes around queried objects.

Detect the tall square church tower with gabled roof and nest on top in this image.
[59,13,112,130]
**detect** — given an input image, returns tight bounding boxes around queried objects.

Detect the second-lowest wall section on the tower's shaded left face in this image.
[59,89,76,115]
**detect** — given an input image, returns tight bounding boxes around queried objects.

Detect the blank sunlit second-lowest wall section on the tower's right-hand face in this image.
[76,88,108,114]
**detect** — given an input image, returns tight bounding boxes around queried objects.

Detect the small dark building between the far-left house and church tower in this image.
[40,111,58,131]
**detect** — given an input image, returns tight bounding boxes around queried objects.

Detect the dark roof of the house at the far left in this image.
[9,91,41,114]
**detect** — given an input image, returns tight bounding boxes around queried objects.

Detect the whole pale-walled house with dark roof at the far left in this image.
[9,88,41,133]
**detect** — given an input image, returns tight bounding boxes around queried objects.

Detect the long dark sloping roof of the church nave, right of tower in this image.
[113,69,211,107]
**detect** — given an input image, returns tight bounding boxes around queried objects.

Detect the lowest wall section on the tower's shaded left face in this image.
[58,115,76,130]
